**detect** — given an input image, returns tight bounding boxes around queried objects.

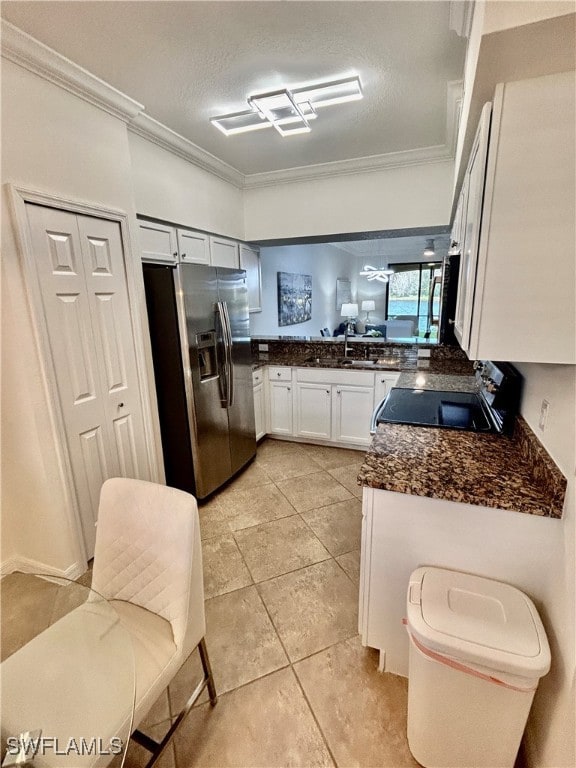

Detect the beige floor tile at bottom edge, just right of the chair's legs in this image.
[175,669,333,768]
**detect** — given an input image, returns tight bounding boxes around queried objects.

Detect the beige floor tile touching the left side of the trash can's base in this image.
[294,638,418,768]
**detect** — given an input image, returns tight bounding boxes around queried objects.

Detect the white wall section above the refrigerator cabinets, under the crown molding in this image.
[128,133,244,240]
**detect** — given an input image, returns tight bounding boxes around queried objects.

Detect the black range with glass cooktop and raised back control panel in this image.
[371,360,522,434]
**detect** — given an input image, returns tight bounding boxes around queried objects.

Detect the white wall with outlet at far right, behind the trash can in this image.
[517,364,576,768]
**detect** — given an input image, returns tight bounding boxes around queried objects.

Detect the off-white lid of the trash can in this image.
[407,567,550,678]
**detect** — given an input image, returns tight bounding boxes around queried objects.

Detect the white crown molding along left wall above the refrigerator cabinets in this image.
[128,112,245,189]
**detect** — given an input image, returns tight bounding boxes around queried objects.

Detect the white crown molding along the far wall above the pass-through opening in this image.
[244,144,454,189]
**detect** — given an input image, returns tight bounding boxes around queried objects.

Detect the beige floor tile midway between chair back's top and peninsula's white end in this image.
[235,515,330,581]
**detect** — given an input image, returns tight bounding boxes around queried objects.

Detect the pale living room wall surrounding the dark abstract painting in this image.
[250,244,357,336]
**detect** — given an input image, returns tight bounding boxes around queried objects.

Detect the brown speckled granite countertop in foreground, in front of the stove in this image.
[358,417,566,518]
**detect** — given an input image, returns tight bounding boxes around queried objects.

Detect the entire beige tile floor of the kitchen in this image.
[126,438,417,768]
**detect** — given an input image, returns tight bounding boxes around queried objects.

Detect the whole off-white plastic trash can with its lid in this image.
[407,567,550,768]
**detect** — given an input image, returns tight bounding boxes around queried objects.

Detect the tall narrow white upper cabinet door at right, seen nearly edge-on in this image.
[454,103,492,352]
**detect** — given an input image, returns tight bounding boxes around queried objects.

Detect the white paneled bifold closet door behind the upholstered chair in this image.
[26,204,149,557]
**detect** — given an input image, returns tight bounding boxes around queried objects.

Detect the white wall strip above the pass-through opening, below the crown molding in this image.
[244,161,454,240]
